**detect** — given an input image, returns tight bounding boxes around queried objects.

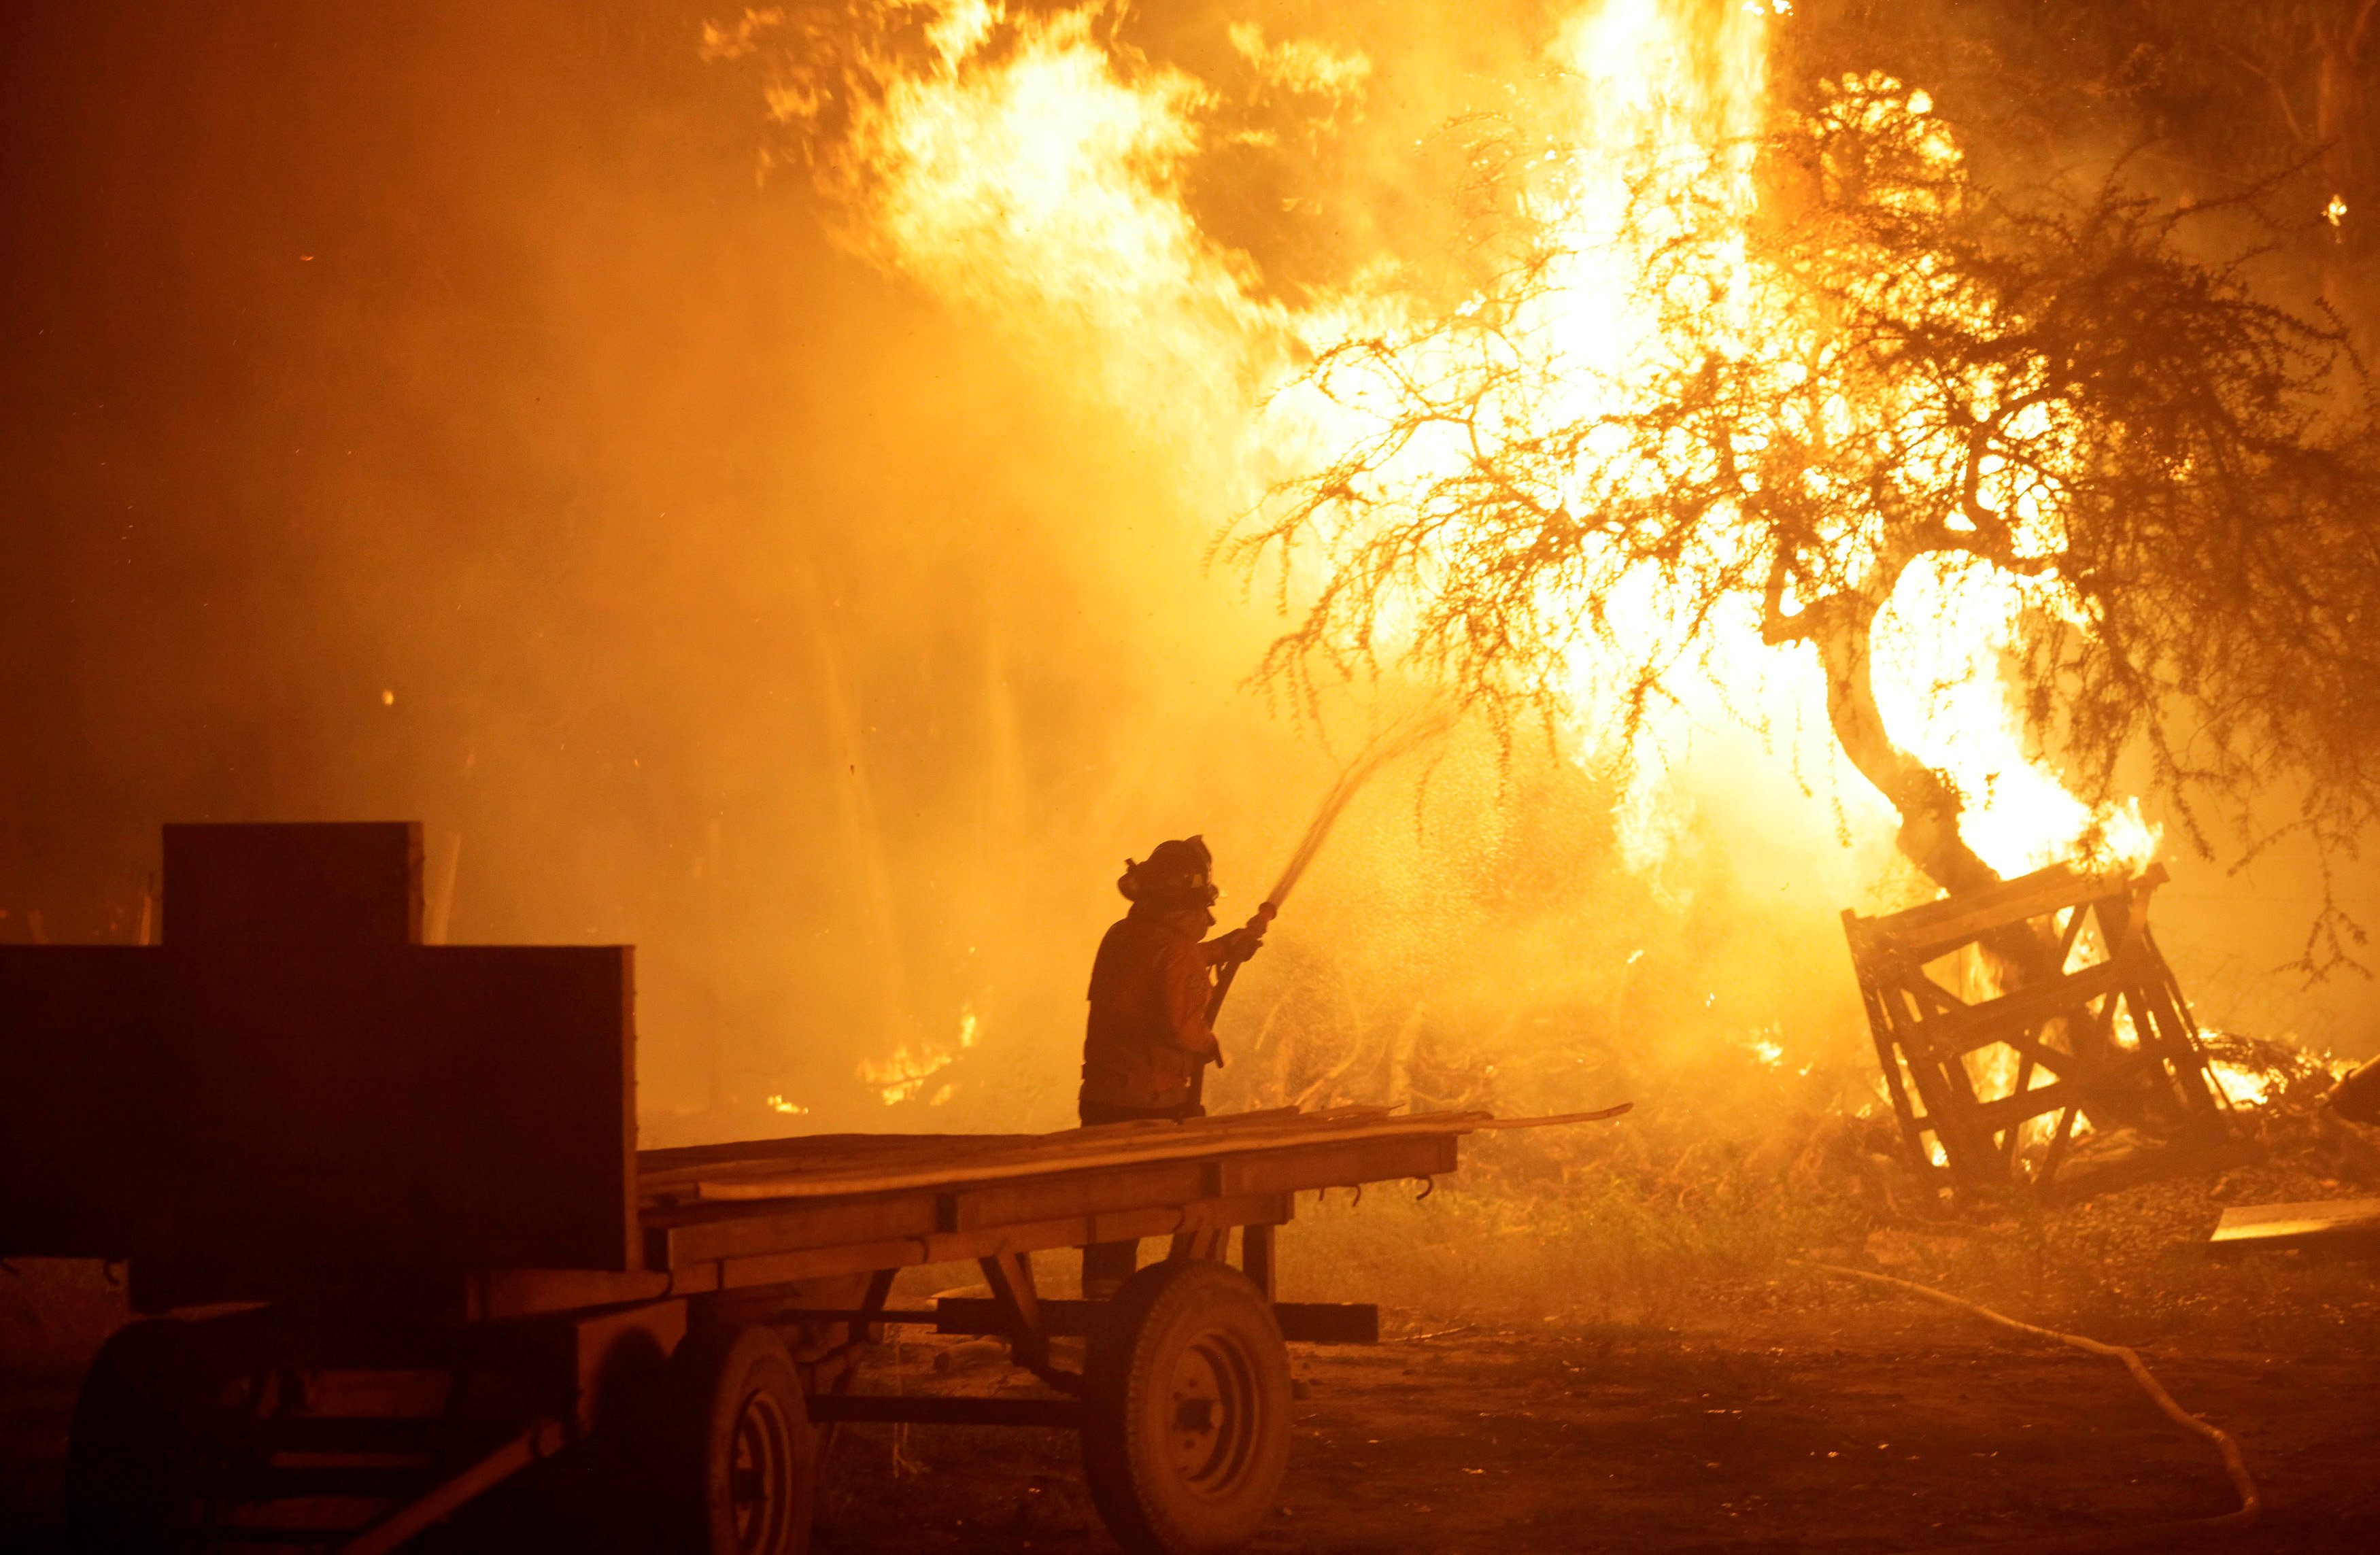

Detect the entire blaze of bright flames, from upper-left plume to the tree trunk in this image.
[707,0,2156,1103]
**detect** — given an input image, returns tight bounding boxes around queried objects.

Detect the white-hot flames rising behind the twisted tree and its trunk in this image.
[1304,15,2159,874]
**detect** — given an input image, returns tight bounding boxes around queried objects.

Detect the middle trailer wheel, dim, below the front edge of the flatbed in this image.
[662,1327,817,1555]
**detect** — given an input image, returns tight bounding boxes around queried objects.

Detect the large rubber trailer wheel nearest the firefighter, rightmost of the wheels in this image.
[1083,1260,1290,1555]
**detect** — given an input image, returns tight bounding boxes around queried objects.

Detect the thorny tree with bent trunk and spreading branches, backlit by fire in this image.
[1228,76,2380,964]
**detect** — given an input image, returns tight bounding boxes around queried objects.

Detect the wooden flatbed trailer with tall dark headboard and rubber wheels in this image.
[0,826,1618,1555]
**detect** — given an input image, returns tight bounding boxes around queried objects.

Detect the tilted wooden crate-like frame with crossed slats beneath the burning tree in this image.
[1842,864,2228,1195]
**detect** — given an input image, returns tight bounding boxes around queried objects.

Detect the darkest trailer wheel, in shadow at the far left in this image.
[67,1322,200,1555]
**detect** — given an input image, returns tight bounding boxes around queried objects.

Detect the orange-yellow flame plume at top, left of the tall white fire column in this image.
[704,0,1314,422]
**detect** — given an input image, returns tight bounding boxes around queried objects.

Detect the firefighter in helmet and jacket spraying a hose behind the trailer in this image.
[1081,836,1264,1300]
